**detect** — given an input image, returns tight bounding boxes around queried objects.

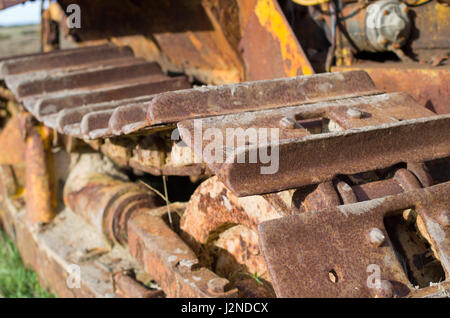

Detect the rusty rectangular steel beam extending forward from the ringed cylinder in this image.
[128,204,237,298]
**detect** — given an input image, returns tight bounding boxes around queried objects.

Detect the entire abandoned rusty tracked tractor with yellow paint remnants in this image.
[0,0,450,298]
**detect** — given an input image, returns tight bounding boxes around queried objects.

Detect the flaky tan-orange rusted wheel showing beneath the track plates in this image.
[180,177,340,290]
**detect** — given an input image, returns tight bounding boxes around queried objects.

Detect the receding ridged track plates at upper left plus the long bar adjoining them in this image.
[2,54,379,139]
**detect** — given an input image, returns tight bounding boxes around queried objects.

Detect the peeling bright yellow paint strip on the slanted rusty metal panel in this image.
[255,0,314,76]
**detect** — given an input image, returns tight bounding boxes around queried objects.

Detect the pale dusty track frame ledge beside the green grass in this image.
[0,153,150,297]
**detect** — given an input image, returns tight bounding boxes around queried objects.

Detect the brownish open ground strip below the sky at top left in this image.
[0,25,40,58]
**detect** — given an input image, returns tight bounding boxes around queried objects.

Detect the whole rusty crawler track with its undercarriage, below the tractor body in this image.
[0,45,450,298]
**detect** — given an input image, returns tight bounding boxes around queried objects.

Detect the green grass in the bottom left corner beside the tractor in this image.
[0,229,55,298]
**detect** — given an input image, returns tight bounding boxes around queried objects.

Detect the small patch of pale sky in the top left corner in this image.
[0,1,41,26]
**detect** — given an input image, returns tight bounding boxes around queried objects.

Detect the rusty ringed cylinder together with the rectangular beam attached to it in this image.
[64,174,237,297]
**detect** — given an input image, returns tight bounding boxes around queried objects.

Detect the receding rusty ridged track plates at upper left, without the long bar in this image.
[0,44,190,139]
